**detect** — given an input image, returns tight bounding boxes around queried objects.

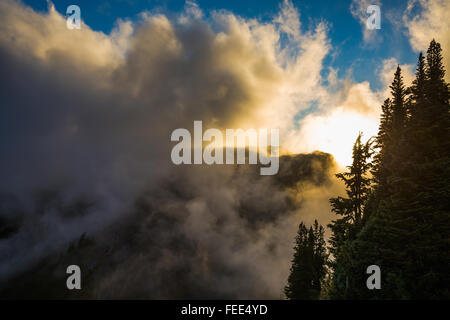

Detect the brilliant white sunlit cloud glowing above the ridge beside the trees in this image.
[284,53,415,167]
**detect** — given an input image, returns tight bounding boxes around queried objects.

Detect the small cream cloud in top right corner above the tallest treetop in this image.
[403,0,450,81]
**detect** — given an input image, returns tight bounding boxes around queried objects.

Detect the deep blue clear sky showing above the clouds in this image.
[23,0,417,90]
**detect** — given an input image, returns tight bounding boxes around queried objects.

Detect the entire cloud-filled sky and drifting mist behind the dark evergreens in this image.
[0,0,450,298]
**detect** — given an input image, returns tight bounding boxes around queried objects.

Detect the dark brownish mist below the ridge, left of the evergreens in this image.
[88,154,340,299]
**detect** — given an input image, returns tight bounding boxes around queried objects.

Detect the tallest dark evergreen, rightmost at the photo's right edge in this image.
[408,39,450,298]
